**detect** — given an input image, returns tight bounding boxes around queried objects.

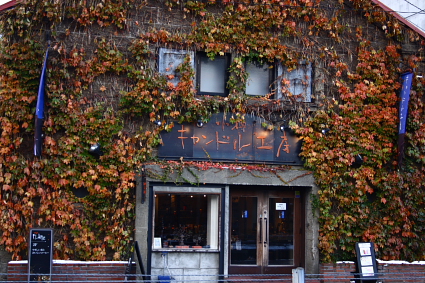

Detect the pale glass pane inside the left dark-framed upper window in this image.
[199,56,227,94]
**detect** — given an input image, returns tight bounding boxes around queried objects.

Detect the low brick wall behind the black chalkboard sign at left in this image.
[7,260,134,282]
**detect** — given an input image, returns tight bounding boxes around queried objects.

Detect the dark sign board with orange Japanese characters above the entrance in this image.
[158,113,302,165]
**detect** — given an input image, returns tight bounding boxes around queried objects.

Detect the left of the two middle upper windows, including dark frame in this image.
[196,53,229,96]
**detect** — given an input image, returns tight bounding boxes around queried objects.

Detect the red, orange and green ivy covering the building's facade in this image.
[0,0,425,261]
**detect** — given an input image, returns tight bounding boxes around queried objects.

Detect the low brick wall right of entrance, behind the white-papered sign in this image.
[320,260,425,283]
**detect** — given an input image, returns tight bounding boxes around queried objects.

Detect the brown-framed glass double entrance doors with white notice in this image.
[229,188,304,274]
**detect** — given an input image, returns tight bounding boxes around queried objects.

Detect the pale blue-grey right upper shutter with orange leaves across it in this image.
[275,63,313,102]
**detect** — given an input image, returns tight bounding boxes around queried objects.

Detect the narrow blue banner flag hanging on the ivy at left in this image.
[34,48,49,156]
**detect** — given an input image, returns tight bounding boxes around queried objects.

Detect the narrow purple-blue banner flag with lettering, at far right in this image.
[398,72,413,166]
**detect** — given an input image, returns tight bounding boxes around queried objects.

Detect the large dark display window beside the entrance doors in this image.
[154,190,220,249]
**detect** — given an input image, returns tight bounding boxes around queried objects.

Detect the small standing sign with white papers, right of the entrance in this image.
[356,243,378,282]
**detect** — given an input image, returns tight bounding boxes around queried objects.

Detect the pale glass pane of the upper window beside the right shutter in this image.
[246,63,270,96]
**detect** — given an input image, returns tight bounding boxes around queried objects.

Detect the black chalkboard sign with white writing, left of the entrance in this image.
[28,228,53,282]
